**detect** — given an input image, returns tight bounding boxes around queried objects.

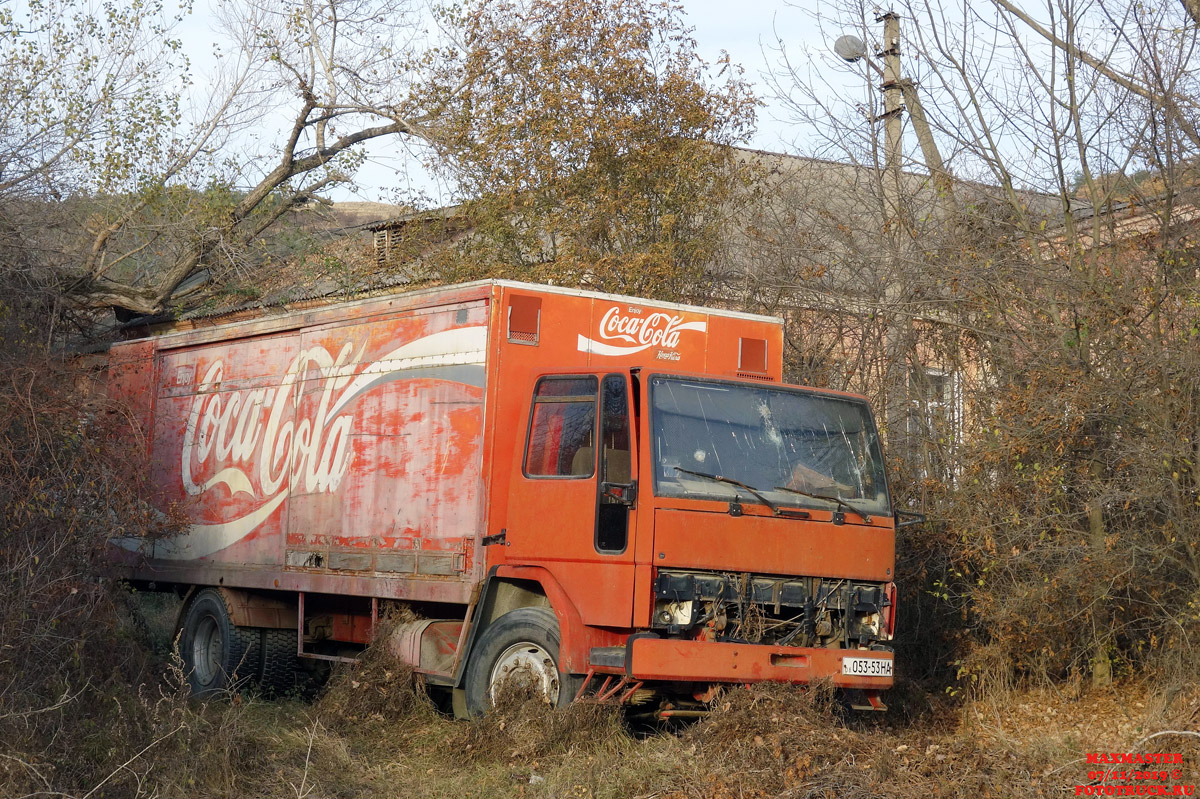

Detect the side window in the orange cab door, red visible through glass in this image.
[524,377,599,477]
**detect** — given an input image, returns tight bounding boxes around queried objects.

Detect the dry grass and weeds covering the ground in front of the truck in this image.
[14,595,1200,799]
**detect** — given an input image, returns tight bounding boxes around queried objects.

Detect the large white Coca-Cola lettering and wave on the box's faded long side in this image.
[112,325,487,560]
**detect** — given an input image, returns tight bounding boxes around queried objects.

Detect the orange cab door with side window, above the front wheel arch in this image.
[505,374,637,626]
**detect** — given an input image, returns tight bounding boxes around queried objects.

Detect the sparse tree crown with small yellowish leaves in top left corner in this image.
[0,0,186,199]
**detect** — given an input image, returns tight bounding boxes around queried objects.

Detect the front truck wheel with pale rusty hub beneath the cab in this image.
[463,607,578,716]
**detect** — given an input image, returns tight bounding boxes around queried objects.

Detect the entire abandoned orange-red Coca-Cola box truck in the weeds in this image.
[107,281,898,716]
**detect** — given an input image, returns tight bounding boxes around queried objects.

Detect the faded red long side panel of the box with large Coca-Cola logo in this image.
[118,293,488,599]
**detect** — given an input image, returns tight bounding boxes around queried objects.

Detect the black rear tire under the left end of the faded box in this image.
[179,588,260,697]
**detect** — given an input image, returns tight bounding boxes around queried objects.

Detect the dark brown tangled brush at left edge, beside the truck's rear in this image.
[0,297,164,795]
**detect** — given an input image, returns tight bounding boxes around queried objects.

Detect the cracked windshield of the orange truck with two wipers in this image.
[650,377,890,516]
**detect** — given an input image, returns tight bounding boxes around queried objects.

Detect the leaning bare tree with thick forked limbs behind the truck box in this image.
[59,0,453,313]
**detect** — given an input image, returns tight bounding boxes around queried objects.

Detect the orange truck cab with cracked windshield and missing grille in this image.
[488,368,895,707]
